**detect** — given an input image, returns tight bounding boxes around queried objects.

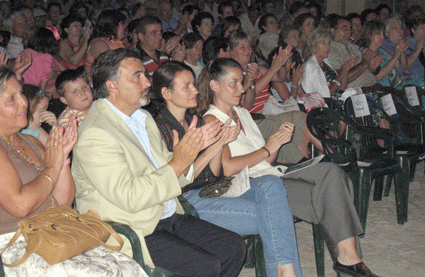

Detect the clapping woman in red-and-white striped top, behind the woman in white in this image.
[230,32,309,163]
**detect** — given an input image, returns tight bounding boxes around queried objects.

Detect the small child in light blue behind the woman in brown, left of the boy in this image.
[21,84,58,146]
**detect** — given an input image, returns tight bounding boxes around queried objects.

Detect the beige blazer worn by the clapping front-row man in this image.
[72,99,189,267]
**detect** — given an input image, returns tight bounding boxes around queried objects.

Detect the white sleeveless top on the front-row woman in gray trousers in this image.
[204,105,272,176]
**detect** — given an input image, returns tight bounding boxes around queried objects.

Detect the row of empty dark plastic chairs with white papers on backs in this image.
[307,86,425,233]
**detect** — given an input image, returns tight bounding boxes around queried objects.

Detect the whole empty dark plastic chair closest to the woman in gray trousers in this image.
[307,108,408,230]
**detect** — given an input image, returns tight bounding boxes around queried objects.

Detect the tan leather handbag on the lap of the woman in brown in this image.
[1,205,124,267]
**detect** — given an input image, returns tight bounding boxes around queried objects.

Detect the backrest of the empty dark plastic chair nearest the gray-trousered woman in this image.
[307,107,357,171]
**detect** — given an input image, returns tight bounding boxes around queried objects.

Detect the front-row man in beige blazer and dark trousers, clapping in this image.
[72,48,245,276]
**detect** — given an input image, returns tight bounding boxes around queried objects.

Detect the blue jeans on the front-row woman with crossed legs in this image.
[183,175,302,277]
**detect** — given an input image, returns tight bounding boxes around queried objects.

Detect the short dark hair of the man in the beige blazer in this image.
[91,48,140,99]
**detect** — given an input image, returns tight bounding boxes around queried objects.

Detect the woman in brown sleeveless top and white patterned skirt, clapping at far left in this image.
[0,66,147,277]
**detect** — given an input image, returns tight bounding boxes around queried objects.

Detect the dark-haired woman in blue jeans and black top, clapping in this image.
[151,62,301,277]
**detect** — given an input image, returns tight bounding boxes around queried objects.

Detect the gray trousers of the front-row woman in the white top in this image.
[282,163,364,261]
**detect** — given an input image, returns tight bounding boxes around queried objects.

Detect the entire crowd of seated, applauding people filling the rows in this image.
[0,0,425,277]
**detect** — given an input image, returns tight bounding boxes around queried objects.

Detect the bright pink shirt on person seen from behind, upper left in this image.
[20,48,53,86]
